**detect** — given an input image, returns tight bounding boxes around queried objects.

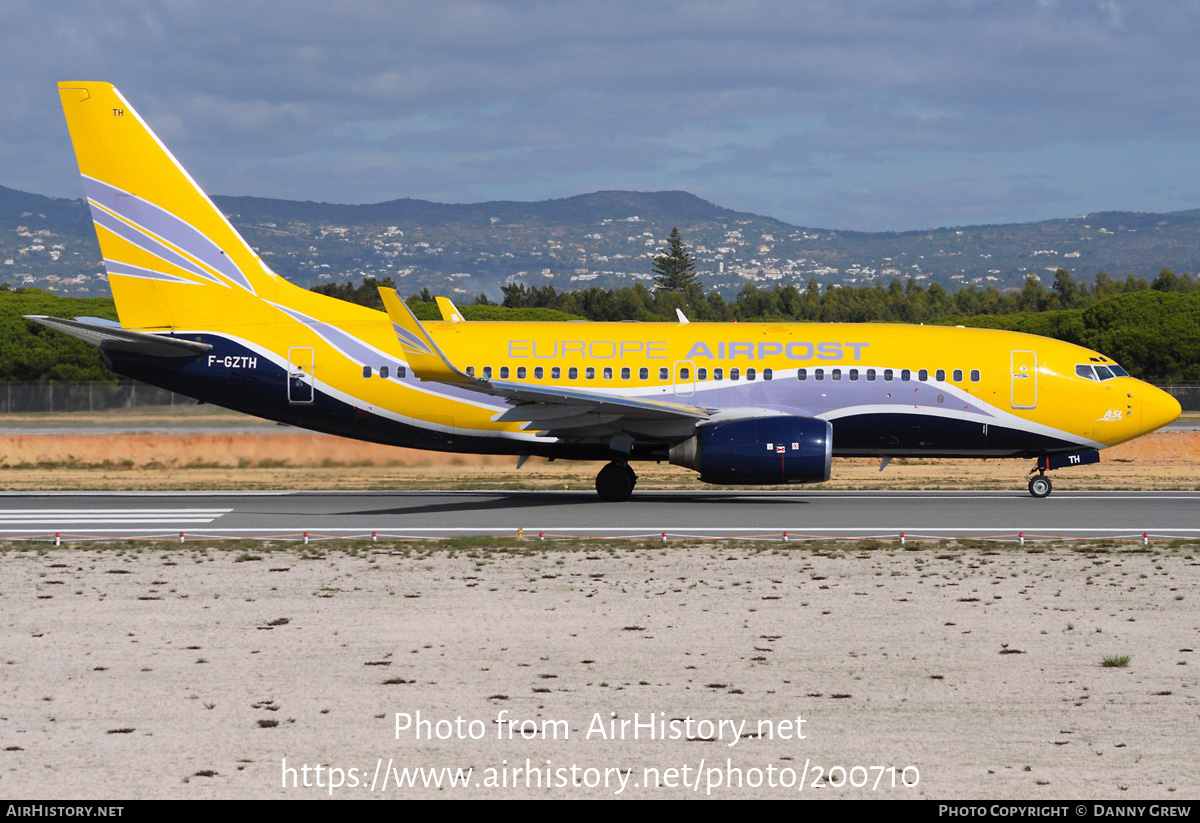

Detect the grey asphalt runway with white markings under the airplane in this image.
[0,489,1200,540]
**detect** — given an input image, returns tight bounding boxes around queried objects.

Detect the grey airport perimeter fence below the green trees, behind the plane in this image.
[0,380,1200,414]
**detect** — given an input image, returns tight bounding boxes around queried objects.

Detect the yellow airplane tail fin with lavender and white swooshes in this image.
[59,82,282,330]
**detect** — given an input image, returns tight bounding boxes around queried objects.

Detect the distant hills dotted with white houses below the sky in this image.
[0,186,1200,299]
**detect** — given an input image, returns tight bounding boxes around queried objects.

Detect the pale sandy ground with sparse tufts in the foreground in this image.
[0,543,1200,800]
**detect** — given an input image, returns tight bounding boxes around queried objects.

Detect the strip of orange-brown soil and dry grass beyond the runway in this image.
[0,429,1200,491]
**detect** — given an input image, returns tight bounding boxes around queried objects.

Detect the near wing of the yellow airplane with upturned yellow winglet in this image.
[379,288,715,444]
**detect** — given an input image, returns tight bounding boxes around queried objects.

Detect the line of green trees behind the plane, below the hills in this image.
[0,269,1200,383]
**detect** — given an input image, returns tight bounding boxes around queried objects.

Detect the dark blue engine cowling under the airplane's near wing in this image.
[671,415,833,485]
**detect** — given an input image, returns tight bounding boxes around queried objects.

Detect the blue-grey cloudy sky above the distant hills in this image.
[0,0,1200,230]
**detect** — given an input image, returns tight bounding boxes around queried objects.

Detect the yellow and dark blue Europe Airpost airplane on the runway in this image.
[30,83,1180,500]
